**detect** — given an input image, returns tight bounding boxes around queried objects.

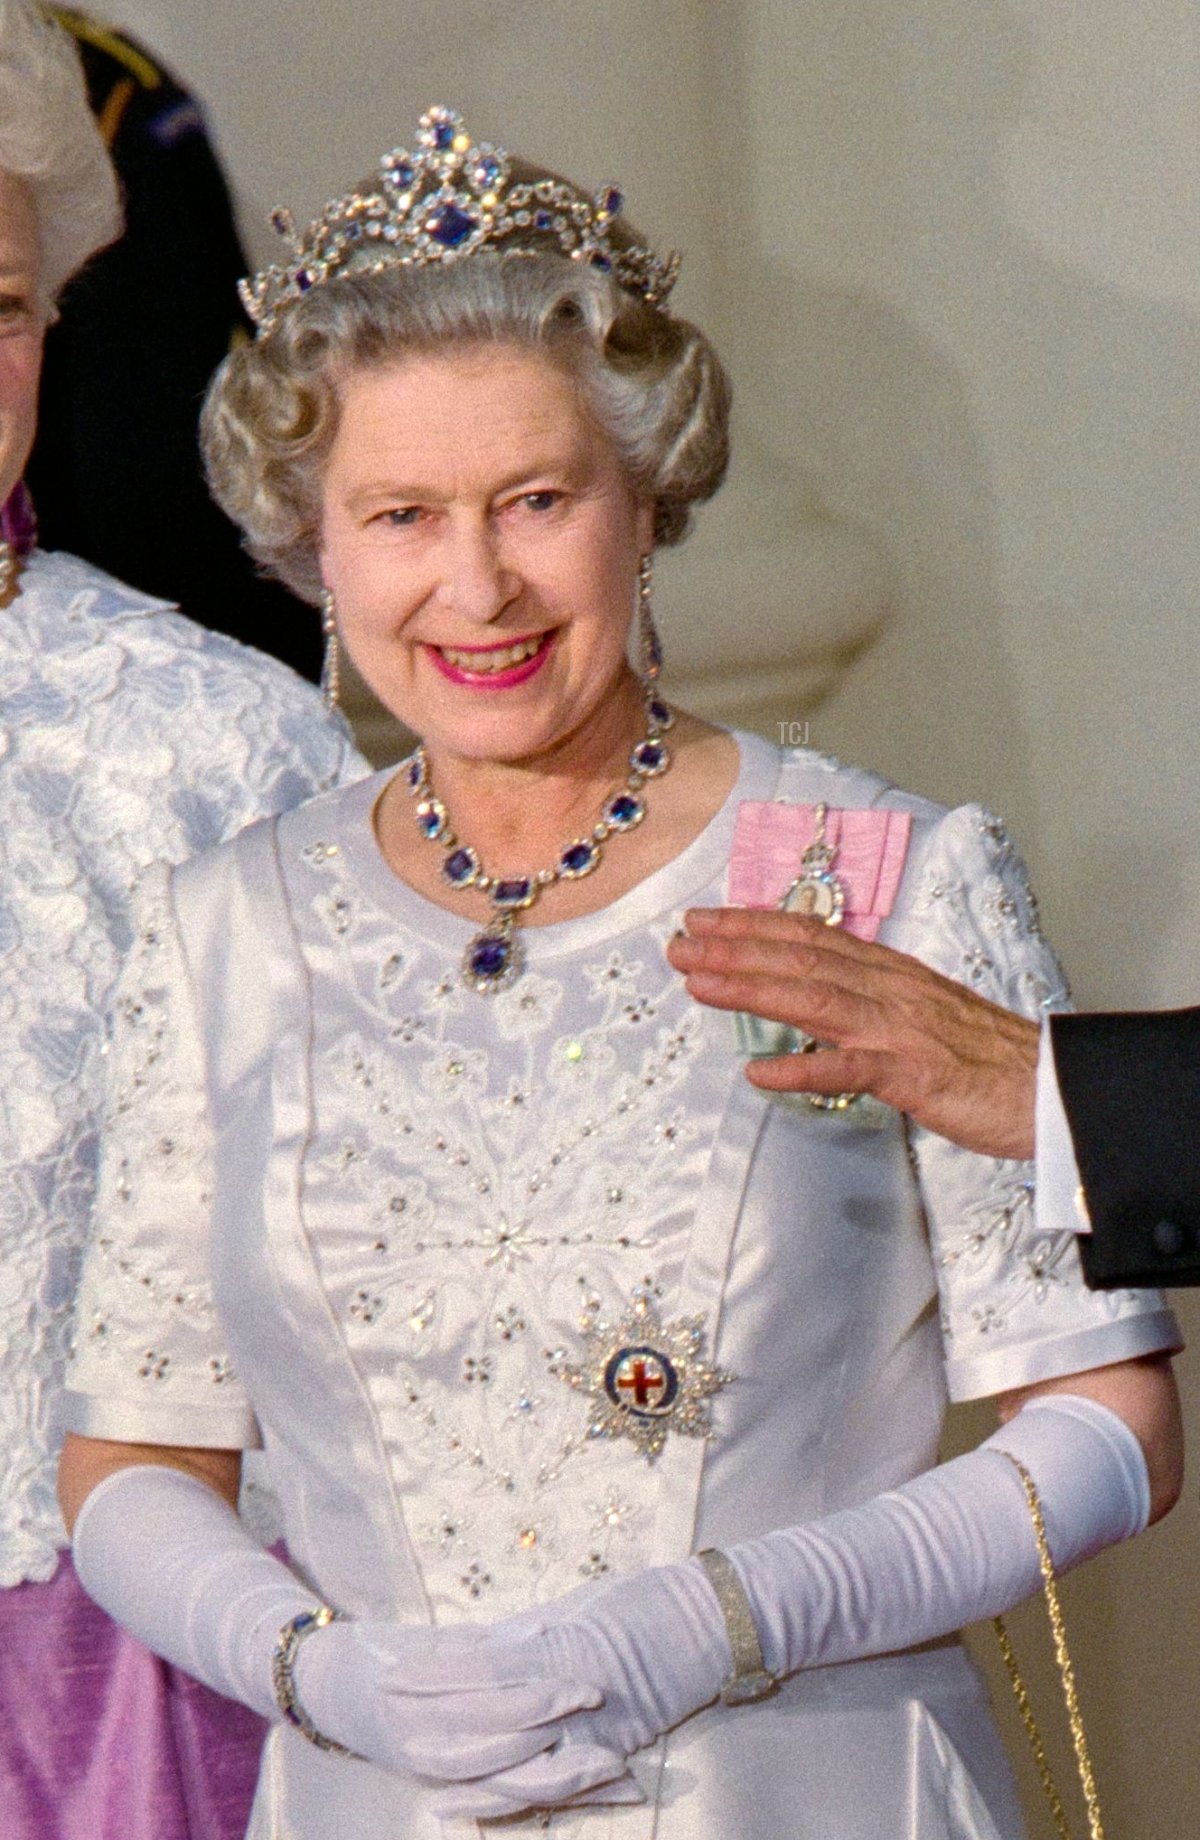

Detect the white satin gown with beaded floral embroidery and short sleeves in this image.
[60,736,1176,1840]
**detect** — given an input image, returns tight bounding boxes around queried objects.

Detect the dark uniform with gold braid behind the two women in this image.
[26,7,320,679]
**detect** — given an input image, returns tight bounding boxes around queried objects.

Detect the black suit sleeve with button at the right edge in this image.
[1051,1008,1200,1290]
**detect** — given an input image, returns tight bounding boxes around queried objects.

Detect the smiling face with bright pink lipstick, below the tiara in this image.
[322,346,653,760]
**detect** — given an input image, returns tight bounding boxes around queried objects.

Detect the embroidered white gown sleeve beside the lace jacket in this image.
[64,865,260,1450]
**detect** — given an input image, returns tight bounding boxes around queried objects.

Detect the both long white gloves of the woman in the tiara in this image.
[75,1395,1150,1818]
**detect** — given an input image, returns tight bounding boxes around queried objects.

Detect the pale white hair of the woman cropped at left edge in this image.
[0,0,121,305]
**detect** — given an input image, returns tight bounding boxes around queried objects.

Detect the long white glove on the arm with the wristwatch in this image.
[428,1395,1150,1816]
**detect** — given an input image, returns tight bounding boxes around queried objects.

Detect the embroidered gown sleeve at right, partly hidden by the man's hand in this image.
[882,806,1180,1398]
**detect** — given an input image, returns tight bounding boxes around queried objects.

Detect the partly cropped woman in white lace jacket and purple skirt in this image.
[0,0,355,1840]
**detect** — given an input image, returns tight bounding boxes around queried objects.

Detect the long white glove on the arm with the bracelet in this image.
[75,1465,720,1812]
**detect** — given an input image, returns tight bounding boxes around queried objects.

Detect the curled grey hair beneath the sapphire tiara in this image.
[201,250,729,602]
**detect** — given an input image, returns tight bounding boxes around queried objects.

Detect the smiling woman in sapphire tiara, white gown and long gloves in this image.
[61,109,1180,1840]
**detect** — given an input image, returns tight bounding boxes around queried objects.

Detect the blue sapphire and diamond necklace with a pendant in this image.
[401,696,675,995]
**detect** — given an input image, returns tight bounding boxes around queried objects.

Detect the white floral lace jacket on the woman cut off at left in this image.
[0,552,363,1584]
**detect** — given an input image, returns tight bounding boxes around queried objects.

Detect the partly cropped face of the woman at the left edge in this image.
[0,171,44,502]
